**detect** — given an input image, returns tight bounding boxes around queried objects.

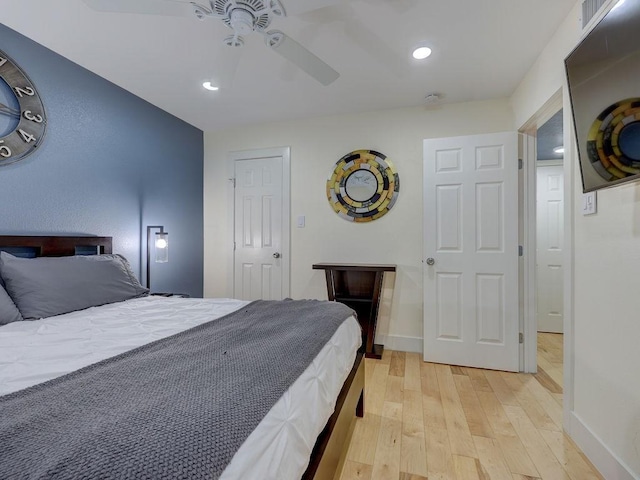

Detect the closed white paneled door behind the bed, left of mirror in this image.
[234,149,289,300]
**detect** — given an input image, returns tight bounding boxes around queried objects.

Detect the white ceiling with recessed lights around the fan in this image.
[0,0,578,131]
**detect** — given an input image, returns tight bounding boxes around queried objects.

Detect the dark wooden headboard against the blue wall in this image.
[0,235,112,257]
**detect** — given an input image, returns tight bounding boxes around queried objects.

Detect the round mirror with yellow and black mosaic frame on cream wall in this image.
[327,150,400,222]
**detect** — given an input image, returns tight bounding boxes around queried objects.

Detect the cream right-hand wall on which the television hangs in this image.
[511,1,640,480]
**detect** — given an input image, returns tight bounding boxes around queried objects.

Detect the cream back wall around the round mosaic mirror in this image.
[204,99,514,351]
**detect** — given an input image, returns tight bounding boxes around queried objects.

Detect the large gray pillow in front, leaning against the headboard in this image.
[0,252,149,320]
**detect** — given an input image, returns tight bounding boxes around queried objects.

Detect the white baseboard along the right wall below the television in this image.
[570,412,640,480]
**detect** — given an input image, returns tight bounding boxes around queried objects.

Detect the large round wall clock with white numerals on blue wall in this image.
[0,51,47,166]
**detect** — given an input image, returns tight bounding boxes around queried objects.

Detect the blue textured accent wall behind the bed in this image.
[0,24,204,297]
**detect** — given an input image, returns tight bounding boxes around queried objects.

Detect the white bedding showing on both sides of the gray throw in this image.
[0,297,361,480]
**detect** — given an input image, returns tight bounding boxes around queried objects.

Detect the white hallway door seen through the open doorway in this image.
[536,163,564,333]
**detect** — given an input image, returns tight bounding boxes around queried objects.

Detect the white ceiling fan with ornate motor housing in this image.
[83,0,340,86]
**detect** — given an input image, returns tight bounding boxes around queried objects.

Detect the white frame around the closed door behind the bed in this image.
[227,147,291,297]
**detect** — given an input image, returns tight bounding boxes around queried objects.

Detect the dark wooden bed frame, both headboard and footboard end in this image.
[0,235,364,480]
